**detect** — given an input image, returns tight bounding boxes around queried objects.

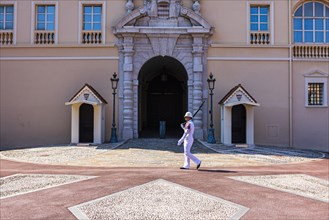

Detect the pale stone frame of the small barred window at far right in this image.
[304,71,328,108]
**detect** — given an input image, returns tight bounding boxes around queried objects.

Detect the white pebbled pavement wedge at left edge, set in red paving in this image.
[0,174,95,199]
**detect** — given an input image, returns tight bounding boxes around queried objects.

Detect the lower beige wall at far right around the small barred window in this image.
[293,61,329,151]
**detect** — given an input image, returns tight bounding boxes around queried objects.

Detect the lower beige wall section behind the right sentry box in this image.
[208,54,289,146]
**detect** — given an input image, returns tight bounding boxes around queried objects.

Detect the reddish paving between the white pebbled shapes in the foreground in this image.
[0,159,329,220]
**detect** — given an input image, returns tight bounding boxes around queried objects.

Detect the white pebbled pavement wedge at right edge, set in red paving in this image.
[229,174,329,203]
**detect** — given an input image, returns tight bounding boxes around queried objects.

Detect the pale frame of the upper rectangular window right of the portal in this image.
[246,1,275,46]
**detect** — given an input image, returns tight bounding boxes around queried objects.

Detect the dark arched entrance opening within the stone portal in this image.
[139,56,187,137]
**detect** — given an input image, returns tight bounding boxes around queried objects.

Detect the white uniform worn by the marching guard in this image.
[178,120,201,169]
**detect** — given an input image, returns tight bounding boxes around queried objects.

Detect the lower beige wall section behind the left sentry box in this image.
[0,48,120,147]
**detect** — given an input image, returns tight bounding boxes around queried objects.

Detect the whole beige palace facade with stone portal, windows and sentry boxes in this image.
[0,0,329,152]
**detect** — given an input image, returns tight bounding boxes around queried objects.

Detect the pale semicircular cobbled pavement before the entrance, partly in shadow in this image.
[0,139,326,167]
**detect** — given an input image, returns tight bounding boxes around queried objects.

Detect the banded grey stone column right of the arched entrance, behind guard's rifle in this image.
[192,35,204,139]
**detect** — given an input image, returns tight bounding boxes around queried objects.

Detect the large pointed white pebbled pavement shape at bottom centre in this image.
[69,179,249,220]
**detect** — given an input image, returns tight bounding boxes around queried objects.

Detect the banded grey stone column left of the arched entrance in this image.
[122,35,134,139]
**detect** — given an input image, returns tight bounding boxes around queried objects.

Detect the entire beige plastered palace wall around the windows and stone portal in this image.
[0,0,329,151]
